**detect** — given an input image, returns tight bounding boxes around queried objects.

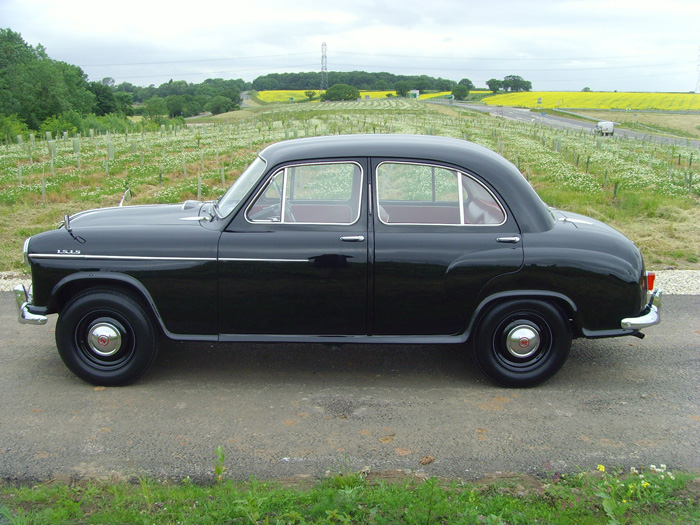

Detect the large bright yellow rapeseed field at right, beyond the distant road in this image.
[483,91,700,111]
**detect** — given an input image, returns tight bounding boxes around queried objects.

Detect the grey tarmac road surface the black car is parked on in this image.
[0,292,700,481]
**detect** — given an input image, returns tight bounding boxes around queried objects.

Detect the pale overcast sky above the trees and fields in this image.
[0,0,700,92]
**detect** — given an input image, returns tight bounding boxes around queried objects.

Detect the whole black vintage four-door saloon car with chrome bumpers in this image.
[15,135,660,387]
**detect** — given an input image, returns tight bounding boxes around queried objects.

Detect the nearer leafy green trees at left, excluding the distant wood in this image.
[0,28,250,138]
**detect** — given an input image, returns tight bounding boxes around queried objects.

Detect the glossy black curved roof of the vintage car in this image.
[260,134,552,232]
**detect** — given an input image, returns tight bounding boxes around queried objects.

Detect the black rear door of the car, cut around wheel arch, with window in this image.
[370,159,523,336]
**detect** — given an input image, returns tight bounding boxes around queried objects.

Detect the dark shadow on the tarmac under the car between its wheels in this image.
[149,341,486,383]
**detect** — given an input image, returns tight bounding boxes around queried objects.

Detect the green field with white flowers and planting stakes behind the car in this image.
[0,97,700,271]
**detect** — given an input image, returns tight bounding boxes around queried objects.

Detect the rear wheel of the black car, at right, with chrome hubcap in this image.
[474,300,571,387]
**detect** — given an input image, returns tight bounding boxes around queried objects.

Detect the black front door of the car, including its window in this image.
[218,160,368,340]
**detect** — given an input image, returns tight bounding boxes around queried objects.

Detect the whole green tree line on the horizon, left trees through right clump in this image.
[0,28,532,138]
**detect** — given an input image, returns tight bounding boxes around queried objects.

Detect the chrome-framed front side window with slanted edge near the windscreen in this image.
[246,162,362,224]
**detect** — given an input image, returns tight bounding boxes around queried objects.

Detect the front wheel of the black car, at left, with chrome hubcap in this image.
[56,290,158,386]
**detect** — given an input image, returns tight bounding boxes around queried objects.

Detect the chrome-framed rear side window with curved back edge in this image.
[377,162,506,226]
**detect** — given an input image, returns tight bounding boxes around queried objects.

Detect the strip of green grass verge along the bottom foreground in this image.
[0,466,700,524]
